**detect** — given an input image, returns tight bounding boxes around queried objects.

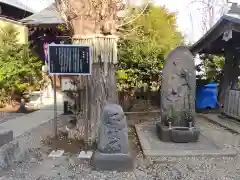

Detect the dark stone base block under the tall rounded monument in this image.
[156,122,200,143]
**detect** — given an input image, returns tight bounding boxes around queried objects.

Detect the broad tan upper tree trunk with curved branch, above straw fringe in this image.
[55,0,149,34]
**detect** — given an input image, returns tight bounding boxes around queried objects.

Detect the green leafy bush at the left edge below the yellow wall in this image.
[0,26,42,105]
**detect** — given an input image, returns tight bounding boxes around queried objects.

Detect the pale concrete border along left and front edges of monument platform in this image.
[135,125,237,157]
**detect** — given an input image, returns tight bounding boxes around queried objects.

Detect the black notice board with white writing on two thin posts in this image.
[48,44,92,146]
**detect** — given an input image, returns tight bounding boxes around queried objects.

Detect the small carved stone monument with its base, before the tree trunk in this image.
[92,104,133,171]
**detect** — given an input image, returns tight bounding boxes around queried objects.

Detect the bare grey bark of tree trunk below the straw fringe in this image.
[88,63,118,140]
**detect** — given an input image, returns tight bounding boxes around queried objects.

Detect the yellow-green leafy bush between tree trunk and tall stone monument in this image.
[117,5,183,92]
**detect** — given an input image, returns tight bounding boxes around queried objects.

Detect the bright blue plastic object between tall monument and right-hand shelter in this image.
[196,84,218,109]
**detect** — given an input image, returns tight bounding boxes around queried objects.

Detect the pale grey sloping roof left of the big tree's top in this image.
[21,3,64,25]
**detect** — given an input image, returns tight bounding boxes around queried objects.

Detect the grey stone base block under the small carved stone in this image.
[92,151,134,171]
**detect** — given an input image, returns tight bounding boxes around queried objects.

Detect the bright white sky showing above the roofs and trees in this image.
[19,0,240,43]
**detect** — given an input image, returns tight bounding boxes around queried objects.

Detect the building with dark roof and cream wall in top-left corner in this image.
[0,0,34,44]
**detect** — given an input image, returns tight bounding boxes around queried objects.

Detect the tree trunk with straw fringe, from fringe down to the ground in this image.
[74,36,118,144]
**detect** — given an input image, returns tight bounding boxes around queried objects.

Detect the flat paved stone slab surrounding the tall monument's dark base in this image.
[135,124,237,157]
